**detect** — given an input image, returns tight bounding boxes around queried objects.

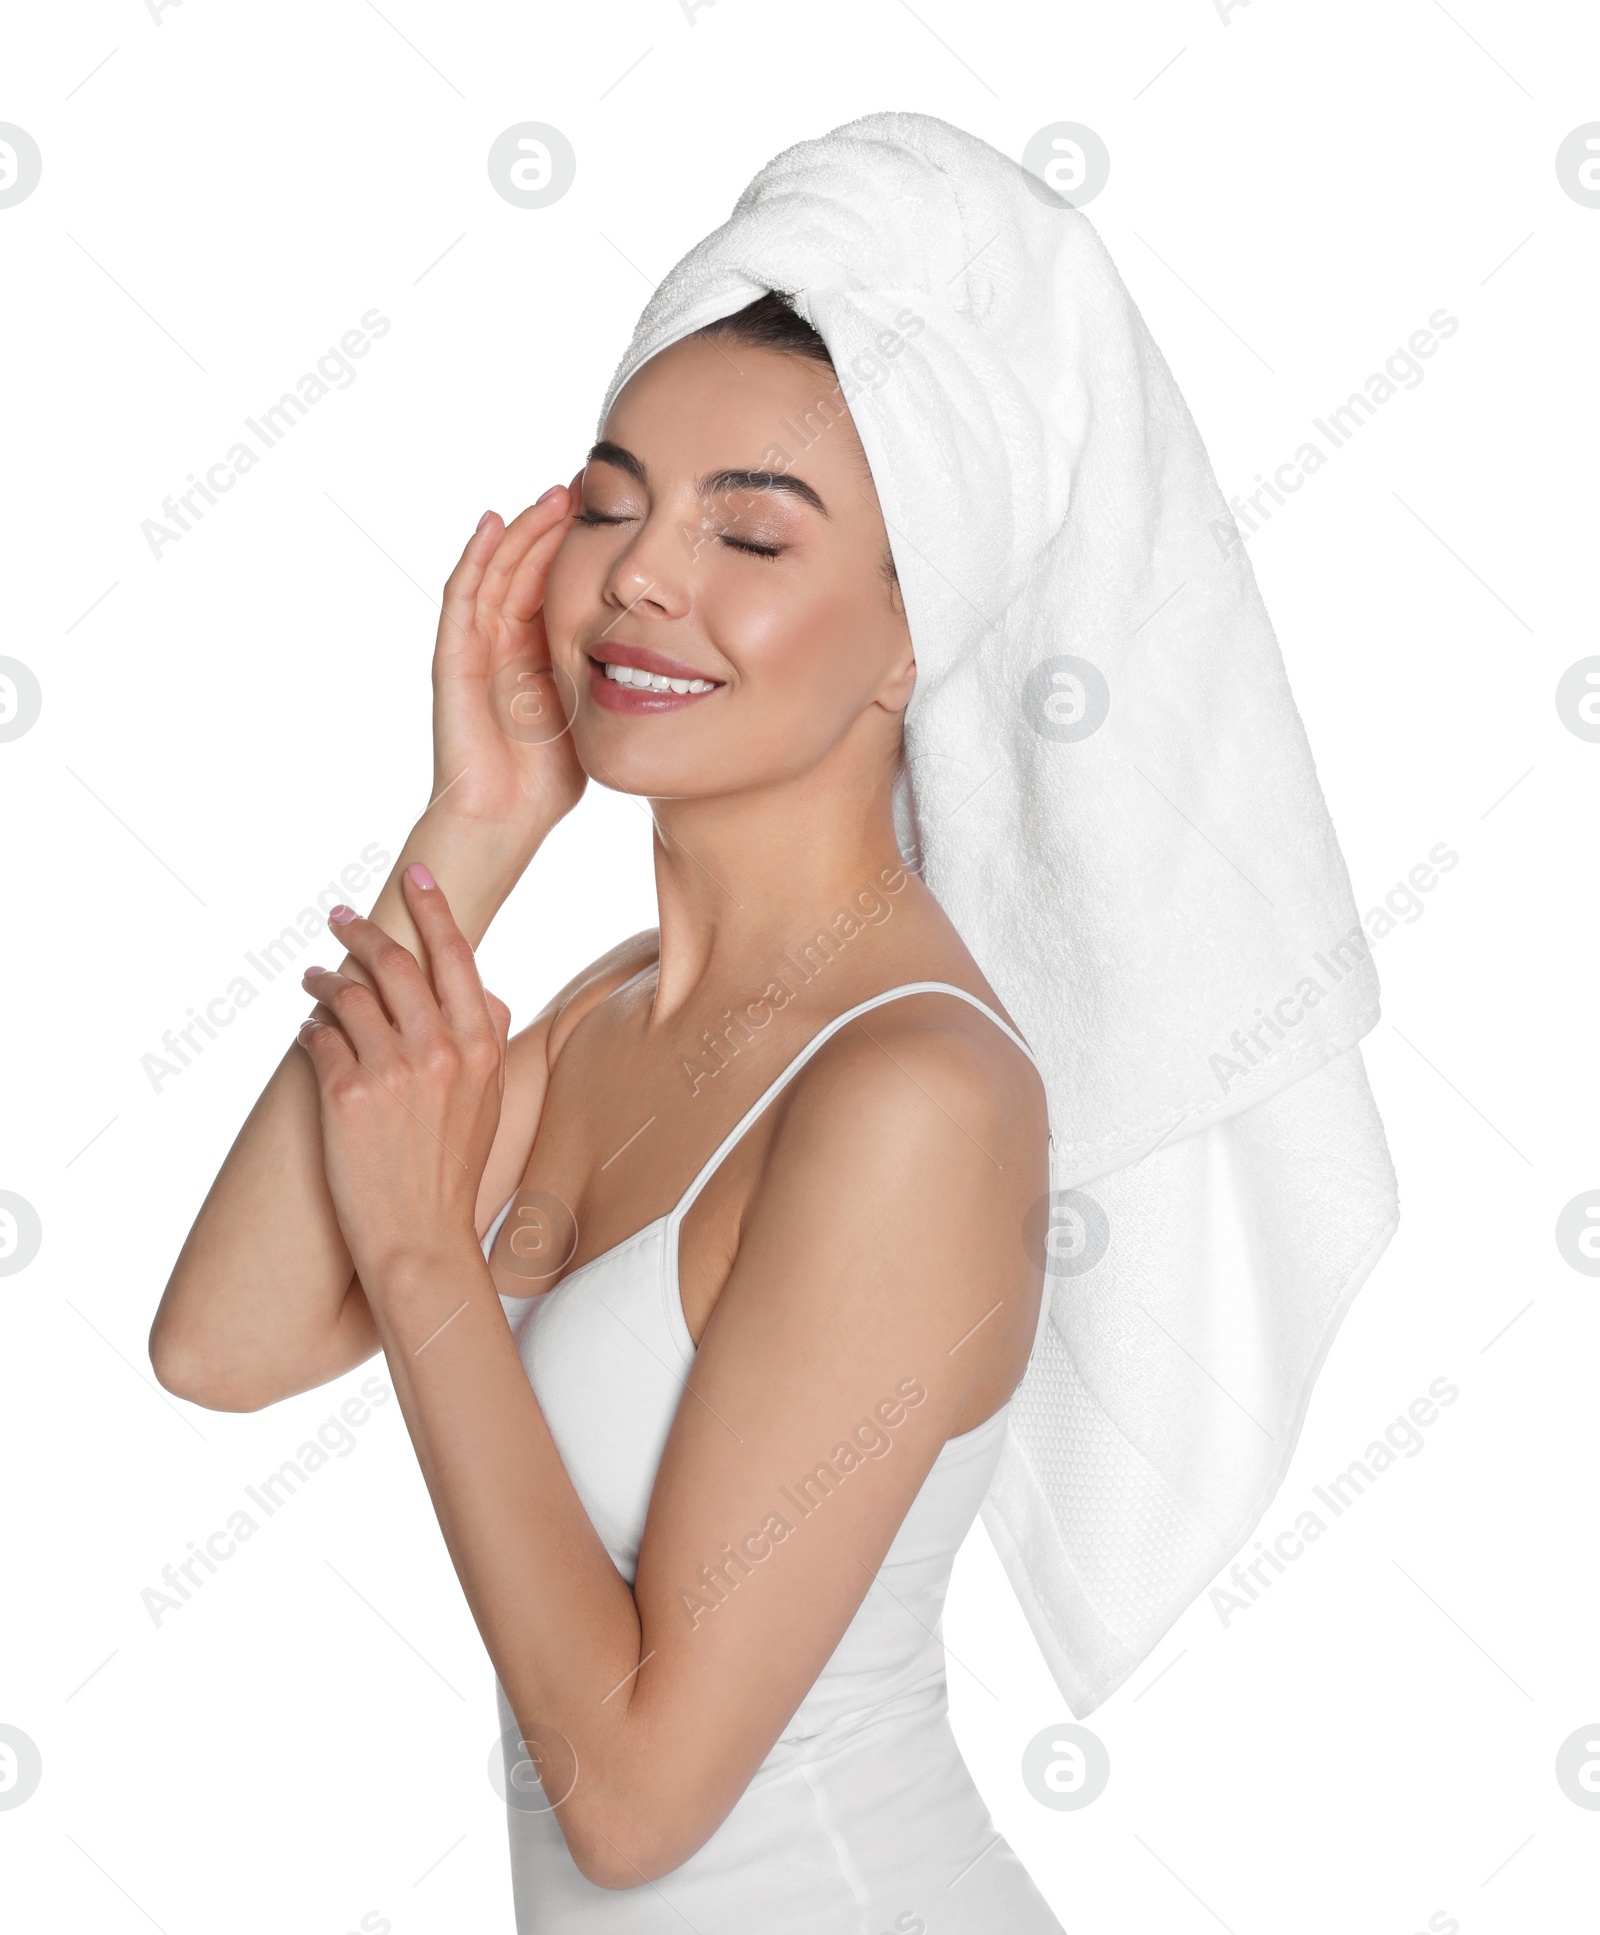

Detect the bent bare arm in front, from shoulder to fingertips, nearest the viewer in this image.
[302,878,1045,1889]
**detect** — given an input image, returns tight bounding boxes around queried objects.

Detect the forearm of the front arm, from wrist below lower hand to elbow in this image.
[373,1248,662,1883]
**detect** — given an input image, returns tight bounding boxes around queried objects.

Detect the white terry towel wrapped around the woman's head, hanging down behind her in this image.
[602,114,1399,1718]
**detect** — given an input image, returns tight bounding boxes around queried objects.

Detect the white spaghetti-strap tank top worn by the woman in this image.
[484,981,1060,1935]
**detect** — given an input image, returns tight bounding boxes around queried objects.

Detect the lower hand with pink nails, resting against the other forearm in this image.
[300,863,511,1296]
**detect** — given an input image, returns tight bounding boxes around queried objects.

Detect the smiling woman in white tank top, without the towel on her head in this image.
[151,294,1060,1935]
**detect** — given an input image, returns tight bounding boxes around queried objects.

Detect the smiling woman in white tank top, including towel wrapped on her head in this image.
[151,114,1397,1935]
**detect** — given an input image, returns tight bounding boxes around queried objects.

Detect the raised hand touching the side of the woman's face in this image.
[430,472,586,849]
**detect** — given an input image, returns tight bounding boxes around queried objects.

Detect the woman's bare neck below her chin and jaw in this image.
[650,739,904,1020]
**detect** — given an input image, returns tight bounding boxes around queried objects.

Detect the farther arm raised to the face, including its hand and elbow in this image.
[149,478,592,1411]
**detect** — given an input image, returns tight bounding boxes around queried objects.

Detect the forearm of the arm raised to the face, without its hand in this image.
[151,809,557,1409]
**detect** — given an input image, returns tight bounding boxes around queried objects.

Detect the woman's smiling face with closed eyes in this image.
[544,337,915,799]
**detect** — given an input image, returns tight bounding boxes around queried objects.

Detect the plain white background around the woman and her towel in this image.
[0,0,1600,1935]
